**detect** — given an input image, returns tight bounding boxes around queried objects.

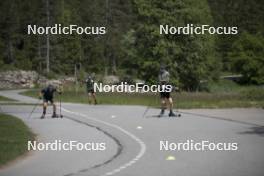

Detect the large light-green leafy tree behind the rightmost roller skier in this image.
[132,0,220,90]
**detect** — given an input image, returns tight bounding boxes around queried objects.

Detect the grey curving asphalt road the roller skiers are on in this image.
[0,91,264,176]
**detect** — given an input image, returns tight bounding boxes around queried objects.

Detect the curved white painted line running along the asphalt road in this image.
[62,108,147,176]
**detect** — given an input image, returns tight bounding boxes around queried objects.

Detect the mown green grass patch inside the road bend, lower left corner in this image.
[0,113,34,166]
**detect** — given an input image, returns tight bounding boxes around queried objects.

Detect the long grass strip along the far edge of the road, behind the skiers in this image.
[23,82,264,109]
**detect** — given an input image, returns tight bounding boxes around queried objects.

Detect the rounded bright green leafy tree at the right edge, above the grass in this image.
[228,32,264,84]
